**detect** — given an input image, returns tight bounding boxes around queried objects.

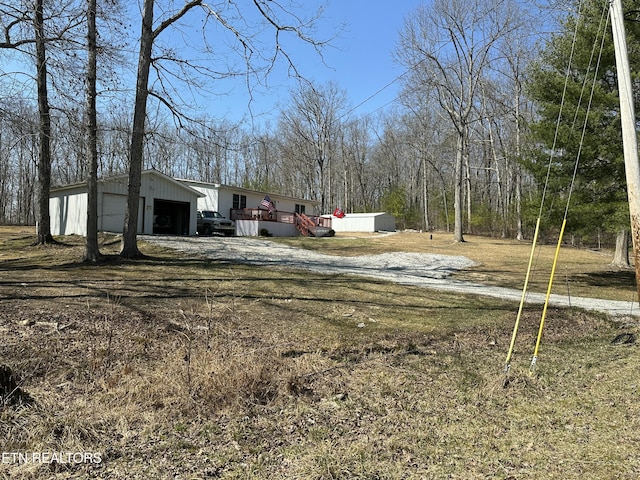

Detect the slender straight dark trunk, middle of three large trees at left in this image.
[83,0,100,262]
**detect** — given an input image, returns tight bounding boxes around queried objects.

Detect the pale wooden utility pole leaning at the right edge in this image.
[610,0,640,301]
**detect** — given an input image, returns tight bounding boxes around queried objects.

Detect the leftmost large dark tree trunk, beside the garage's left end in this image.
[34,0,54,245]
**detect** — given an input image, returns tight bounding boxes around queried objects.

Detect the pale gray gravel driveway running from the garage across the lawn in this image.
[140,236,640,316]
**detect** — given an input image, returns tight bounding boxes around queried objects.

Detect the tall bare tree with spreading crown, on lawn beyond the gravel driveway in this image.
[397,0,515,242]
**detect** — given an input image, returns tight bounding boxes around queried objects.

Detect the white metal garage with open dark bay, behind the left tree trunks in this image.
[49,170,203,235]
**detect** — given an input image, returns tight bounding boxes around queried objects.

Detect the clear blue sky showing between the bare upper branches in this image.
[3,0,428,126]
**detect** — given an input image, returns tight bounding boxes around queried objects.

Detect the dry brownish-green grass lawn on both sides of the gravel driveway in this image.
[0,227,640,479]
